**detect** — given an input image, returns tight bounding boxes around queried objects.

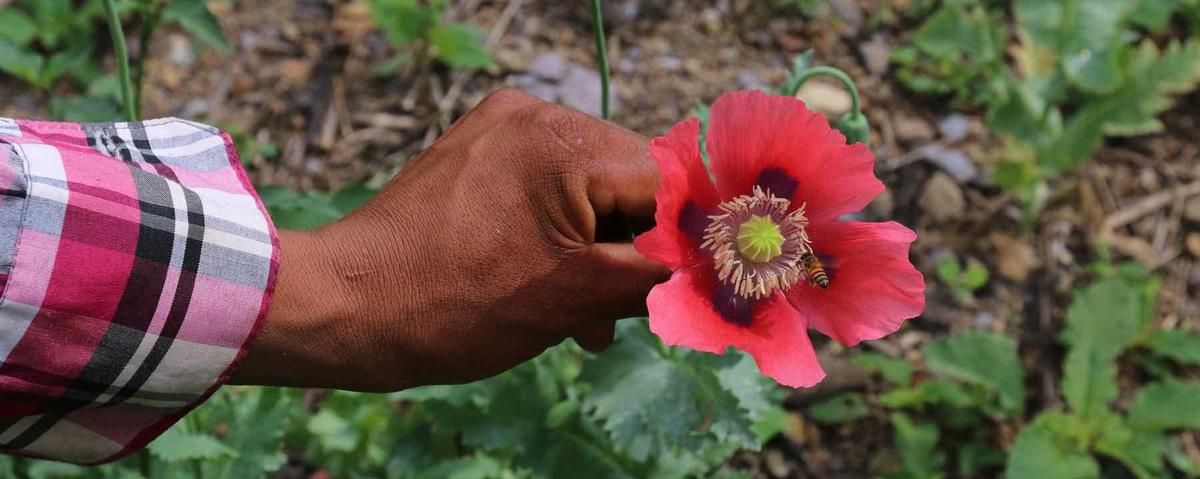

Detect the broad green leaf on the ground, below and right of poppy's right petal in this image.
[924,333,1025,413]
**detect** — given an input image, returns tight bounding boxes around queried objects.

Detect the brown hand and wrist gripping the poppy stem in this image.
[233,90,670,391]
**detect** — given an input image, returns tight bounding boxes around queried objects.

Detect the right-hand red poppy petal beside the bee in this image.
[787,221,925,346]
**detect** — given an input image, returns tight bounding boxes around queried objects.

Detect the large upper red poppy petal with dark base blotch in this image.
[708,90,883,222]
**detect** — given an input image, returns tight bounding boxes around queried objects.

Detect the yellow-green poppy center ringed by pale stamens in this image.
[701,186,812,299]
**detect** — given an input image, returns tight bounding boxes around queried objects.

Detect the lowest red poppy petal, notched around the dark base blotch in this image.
[646,268,824,388]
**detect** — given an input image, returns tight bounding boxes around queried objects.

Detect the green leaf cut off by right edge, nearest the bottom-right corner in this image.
[1129,381,1200,431]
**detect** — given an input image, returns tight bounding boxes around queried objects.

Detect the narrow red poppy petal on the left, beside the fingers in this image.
[634,119,720,269]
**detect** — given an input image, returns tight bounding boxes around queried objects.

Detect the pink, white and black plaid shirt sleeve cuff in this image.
[0,119,278,463]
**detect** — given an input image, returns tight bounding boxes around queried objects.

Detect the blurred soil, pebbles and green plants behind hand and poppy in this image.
[0,0,1200,479]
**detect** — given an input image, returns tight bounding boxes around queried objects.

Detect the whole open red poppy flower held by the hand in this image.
[634,91,925,387]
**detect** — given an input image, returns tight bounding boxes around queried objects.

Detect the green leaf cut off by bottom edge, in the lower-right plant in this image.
[1004,414,1100,479]
